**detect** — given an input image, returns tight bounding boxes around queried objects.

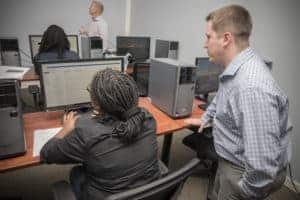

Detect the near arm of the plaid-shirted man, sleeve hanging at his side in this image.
[237,88,285,198]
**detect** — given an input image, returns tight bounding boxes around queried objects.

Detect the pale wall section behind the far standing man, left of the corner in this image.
[0,0,126,65]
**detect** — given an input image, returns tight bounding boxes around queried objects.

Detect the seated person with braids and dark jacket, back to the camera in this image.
[40,69,160,199]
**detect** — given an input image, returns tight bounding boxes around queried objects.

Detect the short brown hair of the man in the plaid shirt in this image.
[206,5,252,41]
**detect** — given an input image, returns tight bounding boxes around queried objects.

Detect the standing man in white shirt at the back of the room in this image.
[79,0,108,51]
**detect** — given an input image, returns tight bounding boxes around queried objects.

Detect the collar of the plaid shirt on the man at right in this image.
[220,47,254,79]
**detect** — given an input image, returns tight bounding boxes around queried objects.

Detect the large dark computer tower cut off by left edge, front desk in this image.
[0,79,26,159]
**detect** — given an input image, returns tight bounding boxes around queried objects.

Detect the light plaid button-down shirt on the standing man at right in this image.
[202,47,289,197]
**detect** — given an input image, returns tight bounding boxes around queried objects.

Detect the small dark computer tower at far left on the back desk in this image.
[0,38,21,66]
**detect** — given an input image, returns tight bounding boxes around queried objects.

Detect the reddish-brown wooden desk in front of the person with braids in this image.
[0,97,204,172]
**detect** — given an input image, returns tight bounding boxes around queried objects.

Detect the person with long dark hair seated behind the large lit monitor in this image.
[33,25,79,72]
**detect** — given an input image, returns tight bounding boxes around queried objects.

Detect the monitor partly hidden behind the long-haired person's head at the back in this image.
[29,35,79,61]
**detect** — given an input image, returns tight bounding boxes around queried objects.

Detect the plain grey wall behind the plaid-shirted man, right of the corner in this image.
[131,0,300,181]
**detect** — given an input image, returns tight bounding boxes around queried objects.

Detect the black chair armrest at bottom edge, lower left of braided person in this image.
[52,181,76,200]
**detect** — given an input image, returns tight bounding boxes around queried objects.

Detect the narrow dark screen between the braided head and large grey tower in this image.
[133,62,150,97]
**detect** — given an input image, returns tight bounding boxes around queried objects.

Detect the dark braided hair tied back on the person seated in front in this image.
[90,69,145,143]
